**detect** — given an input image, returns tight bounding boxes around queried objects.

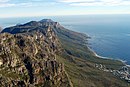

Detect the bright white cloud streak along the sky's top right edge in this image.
[58,0,130,6]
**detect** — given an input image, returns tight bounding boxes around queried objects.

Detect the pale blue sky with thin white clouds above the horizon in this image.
[0,0,130,18]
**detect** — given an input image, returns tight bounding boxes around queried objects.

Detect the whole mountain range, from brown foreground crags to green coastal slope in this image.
[0,19,129,87]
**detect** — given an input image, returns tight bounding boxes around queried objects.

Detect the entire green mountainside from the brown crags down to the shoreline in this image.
[54,26,130,87]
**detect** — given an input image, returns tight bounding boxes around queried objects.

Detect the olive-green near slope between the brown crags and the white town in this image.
[57,56,128,87]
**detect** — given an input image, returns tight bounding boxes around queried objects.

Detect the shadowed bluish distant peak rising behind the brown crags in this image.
[2,19,62,34]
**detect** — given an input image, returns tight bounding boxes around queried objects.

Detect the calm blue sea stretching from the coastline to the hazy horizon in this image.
[0,15,130,65]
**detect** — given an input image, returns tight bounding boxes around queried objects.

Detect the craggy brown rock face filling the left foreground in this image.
[0,26,72,87]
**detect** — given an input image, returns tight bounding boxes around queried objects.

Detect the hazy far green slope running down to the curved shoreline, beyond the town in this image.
[57,27,124,69]
